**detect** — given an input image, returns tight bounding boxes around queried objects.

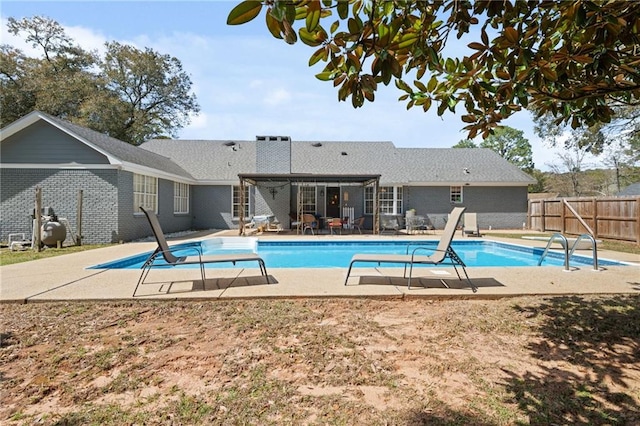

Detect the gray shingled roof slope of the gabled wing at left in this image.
[39,113,193,179]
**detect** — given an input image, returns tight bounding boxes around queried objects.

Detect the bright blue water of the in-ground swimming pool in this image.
[90,238,620,269]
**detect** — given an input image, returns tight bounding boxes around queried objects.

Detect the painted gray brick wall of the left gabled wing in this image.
[0,168,192,245]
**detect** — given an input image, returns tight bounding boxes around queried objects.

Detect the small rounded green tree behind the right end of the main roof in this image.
[480,126,534,173]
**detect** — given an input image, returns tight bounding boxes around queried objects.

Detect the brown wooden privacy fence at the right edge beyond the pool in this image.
[527,197,640,245]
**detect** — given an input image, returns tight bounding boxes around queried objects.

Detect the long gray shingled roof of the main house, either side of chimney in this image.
[141,139,534,185]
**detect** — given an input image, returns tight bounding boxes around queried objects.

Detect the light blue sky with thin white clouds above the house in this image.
[0,0,580,170]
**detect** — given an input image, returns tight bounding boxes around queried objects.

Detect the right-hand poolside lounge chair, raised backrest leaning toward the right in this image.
[344,207,477,293]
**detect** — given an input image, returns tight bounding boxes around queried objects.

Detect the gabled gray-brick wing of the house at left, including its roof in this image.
[0,111,195,243]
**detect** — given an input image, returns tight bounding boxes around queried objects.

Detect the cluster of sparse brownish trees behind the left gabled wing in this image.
[0,16,200,145]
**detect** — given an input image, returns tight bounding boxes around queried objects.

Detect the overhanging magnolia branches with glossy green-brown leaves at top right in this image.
[227,0,640,139]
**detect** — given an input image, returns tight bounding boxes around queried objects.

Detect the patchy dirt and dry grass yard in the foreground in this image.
[0,296,640,425]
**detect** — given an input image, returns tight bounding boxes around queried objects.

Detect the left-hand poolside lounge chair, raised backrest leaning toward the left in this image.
[133,207,271,297]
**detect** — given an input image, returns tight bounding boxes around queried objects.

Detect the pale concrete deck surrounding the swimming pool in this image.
[0,231,640,303]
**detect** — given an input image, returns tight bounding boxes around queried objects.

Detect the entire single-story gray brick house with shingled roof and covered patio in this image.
[0,111,535,243]
